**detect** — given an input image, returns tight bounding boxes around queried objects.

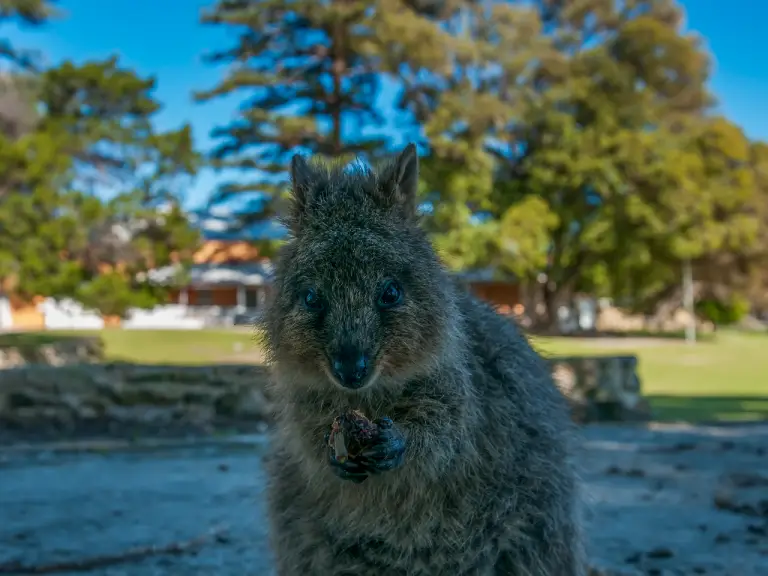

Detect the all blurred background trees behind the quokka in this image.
[0,0,768,325]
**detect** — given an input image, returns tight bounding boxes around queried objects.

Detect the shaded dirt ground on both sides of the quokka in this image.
[0,425,768,576]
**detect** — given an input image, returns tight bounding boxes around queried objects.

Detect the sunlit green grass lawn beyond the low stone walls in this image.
[0,328,768,421]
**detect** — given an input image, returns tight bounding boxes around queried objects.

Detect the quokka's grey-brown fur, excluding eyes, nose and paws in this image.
[266,146,585,576]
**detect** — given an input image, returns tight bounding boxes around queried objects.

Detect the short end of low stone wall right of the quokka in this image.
[549,355,650,423]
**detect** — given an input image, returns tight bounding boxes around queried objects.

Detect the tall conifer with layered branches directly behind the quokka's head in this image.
[197,0,456,232]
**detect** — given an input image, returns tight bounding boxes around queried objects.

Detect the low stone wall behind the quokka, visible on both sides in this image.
[0,356,648,436]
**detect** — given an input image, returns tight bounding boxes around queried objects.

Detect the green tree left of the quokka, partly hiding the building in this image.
[0,58,199,315]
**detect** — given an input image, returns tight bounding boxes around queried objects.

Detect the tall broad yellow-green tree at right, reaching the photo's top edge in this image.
[508,0,711,323]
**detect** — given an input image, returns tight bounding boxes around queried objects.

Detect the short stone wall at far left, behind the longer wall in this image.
[0,333,104,370]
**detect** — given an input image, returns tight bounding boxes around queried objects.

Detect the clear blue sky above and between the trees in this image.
[2,0,768,206]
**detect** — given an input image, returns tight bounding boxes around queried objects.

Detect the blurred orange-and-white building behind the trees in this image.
[0,201,521,329]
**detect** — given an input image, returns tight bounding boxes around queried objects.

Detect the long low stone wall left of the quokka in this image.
[0,363,271,437]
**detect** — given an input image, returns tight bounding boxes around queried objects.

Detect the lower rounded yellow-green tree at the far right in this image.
[588,117,759,311]
